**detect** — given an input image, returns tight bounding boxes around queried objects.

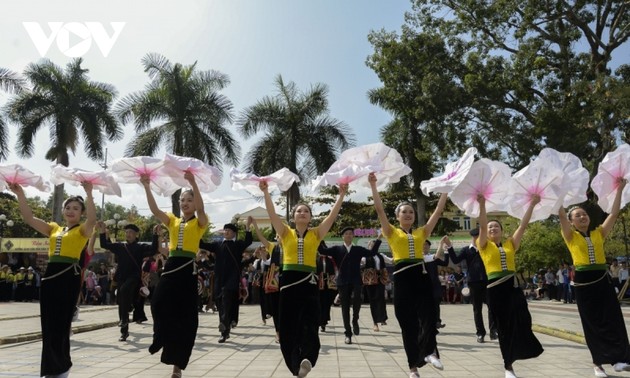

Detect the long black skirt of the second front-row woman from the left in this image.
[149,257,199,369]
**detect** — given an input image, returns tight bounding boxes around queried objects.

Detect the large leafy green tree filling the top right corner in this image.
[406,0,630,171]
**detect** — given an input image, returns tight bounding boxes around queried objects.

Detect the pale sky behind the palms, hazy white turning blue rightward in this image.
[0,0,411,225]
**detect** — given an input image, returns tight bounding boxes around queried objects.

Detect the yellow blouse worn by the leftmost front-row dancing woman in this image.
[48,222,89,262]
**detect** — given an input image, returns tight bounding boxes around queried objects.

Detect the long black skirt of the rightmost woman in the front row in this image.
[574,270,630,365]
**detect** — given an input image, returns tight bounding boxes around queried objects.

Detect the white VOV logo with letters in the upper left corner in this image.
[22,22,126,58]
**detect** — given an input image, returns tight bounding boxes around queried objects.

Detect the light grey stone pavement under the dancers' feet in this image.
[0,301,630,378]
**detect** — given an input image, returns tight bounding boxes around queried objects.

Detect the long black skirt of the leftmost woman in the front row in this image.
[39,263,81,376]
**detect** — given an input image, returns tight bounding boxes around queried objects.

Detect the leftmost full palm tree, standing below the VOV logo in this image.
[7,58,123,222]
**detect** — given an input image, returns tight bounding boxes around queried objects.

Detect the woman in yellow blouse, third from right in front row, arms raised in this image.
[368,173,447,378]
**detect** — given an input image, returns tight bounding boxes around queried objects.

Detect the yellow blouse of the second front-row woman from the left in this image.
[166,213,206,258]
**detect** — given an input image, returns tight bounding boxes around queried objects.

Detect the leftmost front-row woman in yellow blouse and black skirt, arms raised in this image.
[9,182,96,377]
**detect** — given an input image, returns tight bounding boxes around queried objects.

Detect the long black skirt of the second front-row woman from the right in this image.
[487,278,543,369]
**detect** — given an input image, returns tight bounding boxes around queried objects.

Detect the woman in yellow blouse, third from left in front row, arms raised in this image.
[260,181,348,378]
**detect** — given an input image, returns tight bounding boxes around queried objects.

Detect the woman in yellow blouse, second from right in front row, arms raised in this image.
[477,194,543,378]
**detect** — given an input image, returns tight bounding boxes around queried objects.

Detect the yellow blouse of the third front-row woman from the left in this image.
[282,224,321,272]
